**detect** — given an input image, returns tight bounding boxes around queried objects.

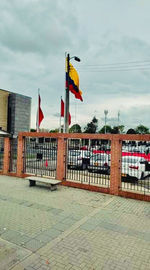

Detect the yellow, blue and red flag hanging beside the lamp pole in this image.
[66,63,83,101]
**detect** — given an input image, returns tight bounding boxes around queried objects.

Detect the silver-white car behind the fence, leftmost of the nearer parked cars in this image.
[68,150,91,170]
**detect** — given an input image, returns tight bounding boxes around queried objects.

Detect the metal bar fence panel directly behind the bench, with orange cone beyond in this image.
[24,137,57,178]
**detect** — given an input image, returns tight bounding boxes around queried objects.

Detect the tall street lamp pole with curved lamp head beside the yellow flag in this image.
[64,53,81,133]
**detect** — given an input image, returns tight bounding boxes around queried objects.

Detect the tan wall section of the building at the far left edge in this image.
[0,89,9,131]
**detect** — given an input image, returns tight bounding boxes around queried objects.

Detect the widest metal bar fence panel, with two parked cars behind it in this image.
[66,139,111,187]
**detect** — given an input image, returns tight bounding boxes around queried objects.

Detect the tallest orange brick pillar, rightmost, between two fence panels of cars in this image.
[110,136,122,195]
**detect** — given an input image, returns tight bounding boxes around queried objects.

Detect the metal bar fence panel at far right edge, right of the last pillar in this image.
[121,141,150,194]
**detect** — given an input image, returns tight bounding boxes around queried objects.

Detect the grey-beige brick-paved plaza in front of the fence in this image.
[0,176,150,270]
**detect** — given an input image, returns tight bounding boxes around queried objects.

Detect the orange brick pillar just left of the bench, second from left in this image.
[17,136,25,177]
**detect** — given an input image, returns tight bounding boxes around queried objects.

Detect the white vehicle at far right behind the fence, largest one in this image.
[122,156,150,180]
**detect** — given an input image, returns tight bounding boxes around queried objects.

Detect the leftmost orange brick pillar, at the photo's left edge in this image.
[3,138,10,174]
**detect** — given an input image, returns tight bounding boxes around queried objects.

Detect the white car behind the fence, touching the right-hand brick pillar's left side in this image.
[88,153,110,174]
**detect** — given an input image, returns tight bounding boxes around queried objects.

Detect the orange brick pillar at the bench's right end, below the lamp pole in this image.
[56,138,66,181]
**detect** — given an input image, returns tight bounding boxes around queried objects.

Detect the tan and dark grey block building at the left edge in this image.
[0,89,31,136]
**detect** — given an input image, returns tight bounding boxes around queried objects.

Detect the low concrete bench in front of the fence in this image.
[26,176,61,191]
